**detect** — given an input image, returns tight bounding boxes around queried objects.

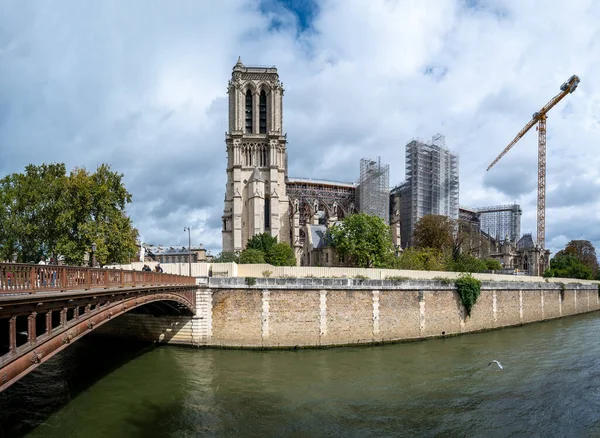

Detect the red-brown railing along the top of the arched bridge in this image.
[0,263,196,295]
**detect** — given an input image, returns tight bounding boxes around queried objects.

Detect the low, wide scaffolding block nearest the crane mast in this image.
[477,204,523,242]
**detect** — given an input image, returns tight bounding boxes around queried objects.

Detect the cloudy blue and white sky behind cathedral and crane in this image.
[0,0,600,254]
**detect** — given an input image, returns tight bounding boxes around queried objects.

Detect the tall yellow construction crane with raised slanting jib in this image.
[486,75,579,250]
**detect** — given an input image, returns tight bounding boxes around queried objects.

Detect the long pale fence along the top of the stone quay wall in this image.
[108,262,598,284]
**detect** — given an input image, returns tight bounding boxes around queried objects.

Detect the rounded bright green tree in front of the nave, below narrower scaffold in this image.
[330,213,394,268]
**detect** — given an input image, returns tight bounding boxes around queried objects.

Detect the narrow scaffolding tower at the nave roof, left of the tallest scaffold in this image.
[357,157,390,225]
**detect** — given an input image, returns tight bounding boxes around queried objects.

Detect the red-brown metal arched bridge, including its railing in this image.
[0,263,196,392]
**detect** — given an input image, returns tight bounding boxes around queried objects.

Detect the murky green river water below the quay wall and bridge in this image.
[0,312,600,438]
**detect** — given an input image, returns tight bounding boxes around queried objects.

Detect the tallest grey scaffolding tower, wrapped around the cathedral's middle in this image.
[393,134,459,248]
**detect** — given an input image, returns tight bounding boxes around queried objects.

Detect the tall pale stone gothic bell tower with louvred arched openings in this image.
[222,59,290,252]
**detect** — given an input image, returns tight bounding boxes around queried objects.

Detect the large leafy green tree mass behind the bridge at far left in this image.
[0,163,138,265]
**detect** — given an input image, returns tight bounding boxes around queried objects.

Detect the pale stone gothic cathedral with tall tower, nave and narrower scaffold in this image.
[222,59,400,266]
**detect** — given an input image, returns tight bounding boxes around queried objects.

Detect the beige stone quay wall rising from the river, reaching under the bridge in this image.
[98,278,600,348]
